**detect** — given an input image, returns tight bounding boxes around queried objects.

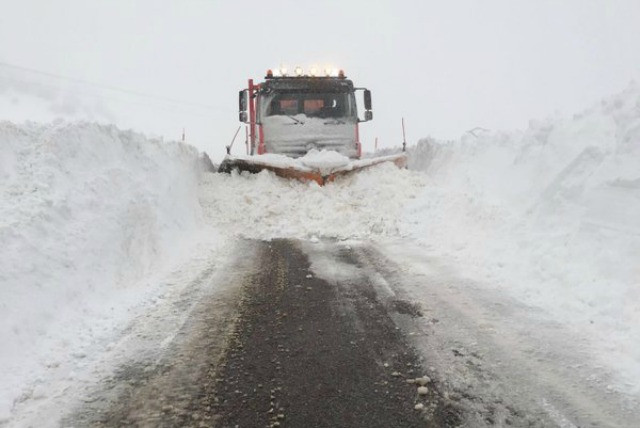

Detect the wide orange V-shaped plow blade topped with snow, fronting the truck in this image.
[218,153,407,186]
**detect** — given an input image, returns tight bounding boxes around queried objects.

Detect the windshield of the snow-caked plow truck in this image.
[263,93,355,118]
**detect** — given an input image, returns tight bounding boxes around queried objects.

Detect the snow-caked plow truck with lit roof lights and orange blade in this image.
[220,67,406,185]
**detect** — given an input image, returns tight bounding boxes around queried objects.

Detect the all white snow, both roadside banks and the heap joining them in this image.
[0,85,640,420]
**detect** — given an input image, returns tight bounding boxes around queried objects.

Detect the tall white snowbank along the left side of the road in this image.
[0,122,201,420]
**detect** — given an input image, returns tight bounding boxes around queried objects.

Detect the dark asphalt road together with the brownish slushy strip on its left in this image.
[64,240,461,427]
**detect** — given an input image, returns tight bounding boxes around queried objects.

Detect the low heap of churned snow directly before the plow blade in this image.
[201,163,425,239]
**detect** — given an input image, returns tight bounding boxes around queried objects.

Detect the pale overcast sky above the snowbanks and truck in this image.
[0,0,640,158]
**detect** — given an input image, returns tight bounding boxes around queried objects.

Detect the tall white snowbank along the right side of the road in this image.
[405,85,640,391]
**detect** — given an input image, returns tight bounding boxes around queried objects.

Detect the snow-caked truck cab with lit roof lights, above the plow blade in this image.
[239,68,373,159]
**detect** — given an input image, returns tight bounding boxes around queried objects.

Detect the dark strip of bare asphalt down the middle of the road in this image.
[212,241,458,427]
